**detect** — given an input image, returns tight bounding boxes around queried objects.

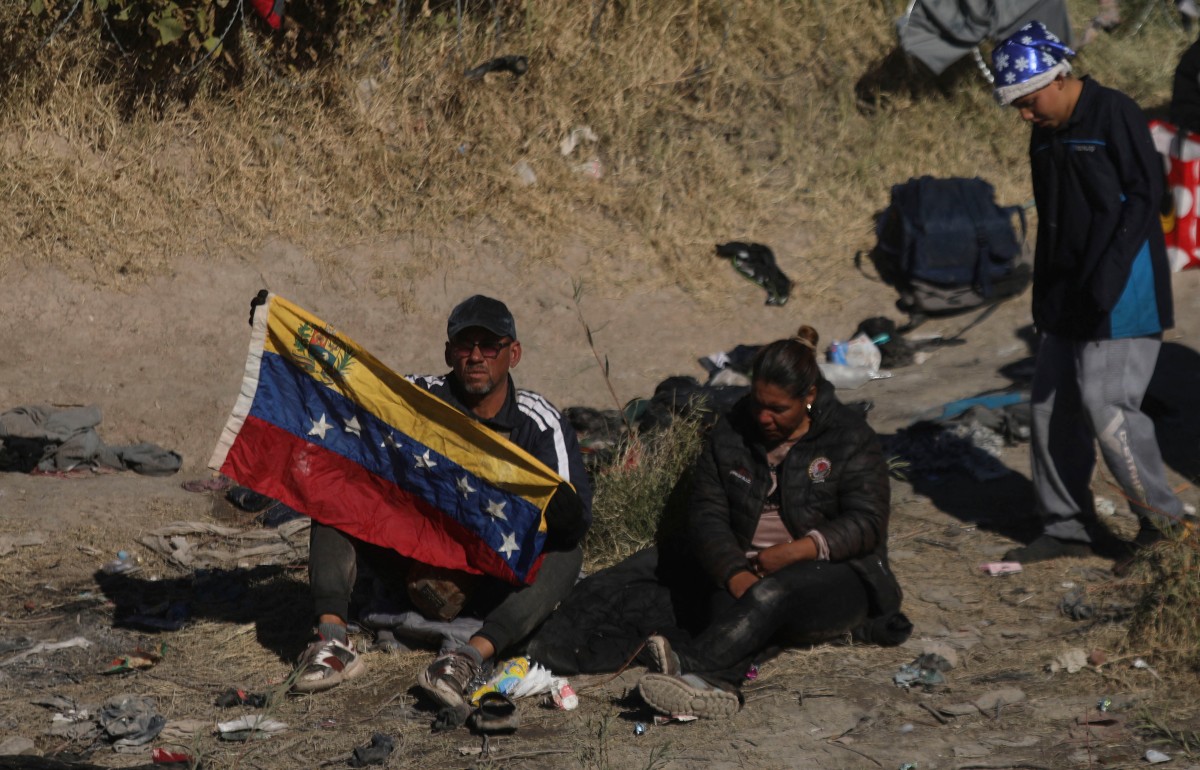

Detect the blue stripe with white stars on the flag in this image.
[250,350,545,579]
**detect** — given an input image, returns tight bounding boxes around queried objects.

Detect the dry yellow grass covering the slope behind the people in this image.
[0,0,1183,303]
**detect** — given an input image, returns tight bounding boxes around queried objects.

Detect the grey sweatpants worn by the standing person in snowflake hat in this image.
[1031,335,1183,542]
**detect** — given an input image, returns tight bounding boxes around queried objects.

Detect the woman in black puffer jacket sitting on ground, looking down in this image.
[638,326,912,717]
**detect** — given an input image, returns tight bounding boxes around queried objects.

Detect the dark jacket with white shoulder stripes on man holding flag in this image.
[407,374,592,549]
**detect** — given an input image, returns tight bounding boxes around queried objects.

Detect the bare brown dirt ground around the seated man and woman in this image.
[0,241,1200,770]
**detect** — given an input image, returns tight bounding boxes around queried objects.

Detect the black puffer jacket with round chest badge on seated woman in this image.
[688,381,900,615]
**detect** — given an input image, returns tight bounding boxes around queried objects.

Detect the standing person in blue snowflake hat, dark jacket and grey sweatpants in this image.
[992,22,1183,563]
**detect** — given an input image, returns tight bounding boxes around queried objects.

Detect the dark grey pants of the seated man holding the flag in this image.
[308,522,583,654]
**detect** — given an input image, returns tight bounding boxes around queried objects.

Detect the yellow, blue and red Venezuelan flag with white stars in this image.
[209,294,562,584]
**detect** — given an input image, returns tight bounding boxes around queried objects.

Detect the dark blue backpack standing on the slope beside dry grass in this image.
[871,176,1032,314]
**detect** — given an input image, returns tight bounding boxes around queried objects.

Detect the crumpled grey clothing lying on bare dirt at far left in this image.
[0,407,184,476]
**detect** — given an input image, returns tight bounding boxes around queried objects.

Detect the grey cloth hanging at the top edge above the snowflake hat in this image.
[896,0,1072,74]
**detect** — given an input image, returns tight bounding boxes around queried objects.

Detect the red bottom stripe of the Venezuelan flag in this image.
[221,416,540,583]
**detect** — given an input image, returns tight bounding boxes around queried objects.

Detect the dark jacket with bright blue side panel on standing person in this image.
[1030,78,1175,341]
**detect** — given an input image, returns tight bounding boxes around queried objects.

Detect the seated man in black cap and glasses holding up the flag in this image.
[293,294,592,708]
